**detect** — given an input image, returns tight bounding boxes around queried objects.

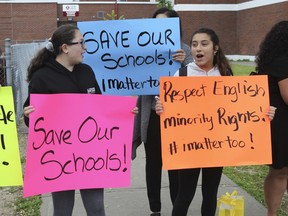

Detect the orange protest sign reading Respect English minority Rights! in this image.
[160,76,272,169]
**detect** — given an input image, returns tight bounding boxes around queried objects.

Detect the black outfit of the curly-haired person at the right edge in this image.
[259,57,288,169]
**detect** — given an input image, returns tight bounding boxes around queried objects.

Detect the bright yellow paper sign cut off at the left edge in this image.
[0,86,23,186]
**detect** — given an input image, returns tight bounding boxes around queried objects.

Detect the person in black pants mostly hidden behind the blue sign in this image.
[132,8,193,216]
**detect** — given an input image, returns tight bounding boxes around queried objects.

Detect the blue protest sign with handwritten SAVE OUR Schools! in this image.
[78,18,181,95]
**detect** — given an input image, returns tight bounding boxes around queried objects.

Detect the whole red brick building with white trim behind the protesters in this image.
[0,0,288,55]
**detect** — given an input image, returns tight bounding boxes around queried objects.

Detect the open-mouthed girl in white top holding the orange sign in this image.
[155,28,275,216]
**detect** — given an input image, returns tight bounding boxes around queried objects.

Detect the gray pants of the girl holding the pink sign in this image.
[52,188,105,216]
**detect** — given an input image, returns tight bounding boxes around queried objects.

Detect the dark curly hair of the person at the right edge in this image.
[255,21,288,73]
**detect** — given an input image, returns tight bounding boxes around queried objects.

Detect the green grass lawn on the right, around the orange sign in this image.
[223,62,288,216]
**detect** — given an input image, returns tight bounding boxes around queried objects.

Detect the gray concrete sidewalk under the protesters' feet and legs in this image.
[41,145,266,216]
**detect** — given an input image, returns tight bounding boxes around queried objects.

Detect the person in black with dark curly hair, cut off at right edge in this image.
[256,21,288,216]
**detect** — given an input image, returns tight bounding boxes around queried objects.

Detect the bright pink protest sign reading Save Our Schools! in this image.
[24,94,136,197]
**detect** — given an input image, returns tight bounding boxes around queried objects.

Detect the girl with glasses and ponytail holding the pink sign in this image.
[24,25,137,216]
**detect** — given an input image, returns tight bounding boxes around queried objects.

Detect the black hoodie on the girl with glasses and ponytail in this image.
[24,59,101,125]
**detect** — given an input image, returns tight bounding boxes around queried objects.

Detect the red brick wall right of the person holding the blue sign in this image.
[174,0,288,55]
